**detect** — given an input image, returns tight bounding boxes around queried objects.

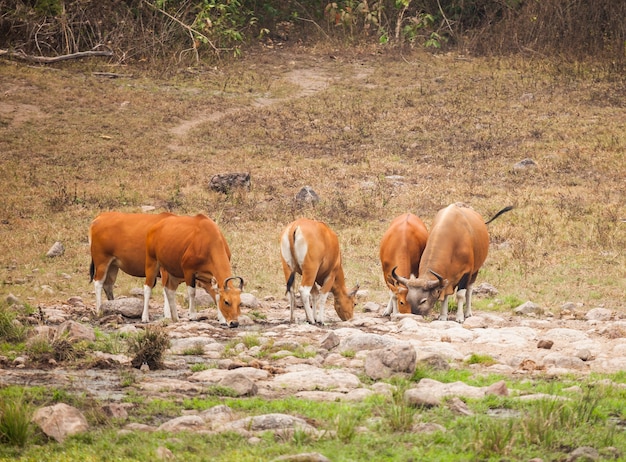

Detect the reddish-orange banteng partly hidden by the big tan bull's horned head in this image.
[380,213,428,316]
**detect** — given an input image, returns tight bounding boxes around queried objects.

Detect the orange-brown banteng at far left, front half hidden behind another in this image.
[89,212,174,316]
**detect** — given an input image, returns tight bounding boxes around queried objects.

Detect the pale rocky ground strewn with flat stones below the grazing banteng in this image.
[0,288,626,444]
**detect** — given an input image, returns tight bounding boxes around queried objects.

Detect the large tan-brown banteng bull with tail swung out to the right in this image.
[391,203,513,323]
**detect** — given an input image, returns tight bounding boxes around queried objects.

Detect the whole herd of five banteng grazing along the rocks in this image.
[89,203,512,327]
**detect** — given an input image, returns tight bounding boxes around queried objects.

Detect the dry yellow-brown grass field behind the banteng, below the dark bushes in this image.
[0,48,626,312]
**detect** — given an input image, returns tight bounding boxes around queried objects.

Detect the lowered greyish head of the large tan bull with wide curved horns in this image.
[391,268,448,316]
